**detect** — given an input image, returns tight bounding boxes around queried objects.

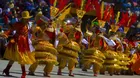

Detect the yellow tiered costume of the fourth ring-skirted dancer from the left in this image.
[100,36,119,75]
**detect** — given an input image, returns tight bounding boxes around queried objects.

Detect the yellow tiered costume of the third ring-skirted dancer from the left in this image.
[82,32,105,76]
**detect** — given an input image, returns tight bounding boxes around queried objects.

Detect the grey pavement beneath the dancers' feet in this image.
[0,60,140,78]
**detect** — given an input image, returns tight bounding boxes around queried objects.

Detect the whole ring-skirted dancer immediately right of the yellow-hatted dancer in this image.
[29,14,58,77]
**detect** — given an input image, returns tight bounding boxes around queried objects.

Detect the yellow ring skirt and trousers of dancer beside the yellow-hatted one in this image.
[29,40,58,73]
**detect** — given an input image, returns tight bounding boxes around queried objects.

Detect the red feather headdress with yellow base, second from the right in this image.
[94,0,114,28]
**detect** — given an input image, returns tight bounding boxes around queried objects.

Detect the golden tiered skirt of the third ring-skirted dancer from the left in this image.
[82,48,105,68]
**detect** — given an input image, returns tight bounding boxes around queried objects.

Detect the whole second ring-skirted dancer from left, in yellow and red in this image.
[57,19,81,77]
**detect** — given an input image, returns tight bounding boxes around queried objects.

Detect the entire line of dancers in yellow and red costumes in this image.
[0,11,140,78]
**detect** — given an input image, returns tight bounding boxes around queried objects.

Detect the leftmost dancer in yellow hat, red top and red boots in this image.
[3,11,35,78]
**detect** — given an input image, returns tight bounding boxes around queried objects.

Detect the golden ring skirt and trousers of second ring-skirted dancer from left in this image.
[57,41,81,70]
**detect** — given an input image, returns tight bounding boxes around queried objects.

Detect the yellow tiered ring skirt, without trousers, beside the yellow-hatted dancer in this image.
[34,40,58,65]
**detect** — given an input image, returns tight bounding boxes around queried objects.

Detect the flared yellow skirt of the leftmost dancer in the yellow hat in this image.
[4,44,35,64]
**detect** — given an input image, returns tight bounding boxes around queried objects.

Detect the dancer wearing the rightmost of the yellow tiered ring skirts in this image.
[111,31,130,75]
